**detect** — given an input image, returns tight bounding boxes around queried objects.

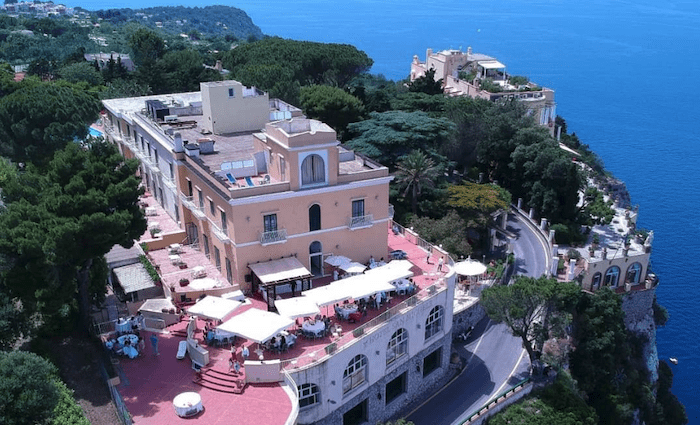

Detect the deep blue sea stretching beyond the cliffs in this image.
[69,0,700,424]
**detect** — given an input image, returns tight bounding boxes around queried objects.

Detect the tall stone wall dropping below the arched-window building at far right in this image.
[622,288,659,382]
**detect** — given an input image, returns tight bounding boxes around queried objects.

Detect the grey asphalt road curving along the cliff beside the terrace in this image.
[406,214,548,425]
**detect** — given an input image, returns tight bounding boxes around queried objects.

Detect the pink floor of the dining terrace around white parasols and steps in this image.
[112,215,447,425]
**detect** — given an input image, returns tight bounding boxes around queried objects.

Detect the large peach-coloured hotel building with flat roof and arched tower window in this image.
[103,81,392,300]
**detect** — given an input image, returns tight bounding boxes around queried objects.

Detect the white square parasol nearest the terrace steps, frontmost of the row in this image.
[216,308,294,344]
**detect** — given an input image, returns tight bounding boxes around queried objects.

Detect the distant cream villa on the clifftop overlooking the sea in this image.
[410,47,556,134]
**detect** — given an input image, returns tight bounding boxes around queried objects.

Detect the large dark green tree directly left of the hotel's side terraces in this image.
[0,142,146,328]
